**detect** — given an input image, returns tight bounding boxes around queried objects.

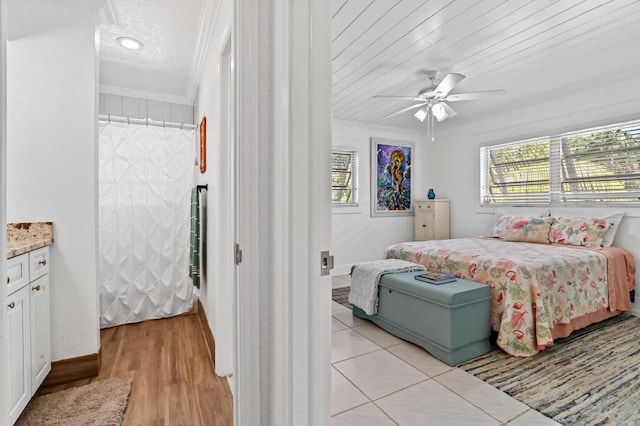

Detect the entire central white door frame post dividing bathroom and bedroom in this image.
[234,0,331,426]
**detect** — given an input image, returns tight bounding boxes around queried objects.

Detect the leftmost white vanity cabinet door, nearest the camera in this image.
[5,285,32,424]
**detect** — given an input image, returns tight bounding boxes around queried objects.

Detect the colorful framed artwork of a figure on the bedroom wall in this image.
[371,138,413,217]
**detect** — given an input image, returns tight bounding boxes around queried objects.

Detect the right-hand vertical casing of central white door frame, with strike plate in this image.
[288,0,331,425]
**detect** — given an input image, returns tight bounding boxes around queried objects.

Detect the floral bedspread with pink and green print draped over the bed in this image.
[385,238,609,357]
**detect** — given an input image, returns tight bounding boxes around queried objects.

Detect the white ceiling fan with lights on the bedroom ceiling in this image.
[374,71,504,121]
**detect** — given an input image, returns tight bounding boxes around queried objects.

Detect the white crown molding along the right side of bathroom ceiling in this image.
[187,0,222,103]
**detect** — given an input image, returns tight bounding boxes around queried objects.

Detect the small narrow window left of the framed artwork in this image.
[331,149,358,207]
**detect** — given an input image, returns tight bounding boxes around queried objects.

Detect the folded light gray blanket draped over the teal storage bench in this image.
[349,259,426,315]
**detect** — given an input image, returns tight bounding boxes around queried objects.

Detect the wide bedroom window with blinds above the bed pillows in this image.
[480,121,640,205]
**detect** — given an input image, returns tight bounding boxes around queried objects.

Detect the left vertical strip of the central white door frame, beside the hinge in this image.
[233,0,262,426]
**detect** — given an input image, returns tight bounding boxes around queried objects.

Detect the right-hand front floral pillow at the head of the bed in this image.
[549,217,611,247]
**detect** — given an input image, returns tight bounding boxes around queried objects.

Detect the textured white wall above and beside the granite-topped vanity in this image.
[7,18,100,361]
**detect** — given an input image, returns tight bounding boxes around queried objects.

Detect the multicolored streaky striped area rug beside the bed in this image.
[459,314,640,426]
